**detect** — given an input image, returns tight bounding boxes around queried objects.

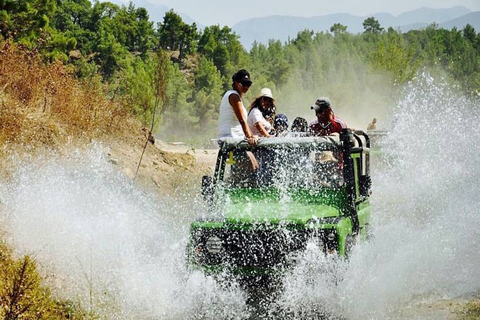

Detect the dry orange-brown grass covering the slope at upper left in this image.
[0,41,136,148]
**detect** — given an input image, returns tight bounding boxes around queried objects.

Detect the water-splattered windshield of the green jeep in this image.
[217,136,344,190]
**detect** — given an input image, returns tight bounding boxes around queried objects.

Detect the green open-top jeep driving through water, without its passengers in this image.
[187,129,372,276]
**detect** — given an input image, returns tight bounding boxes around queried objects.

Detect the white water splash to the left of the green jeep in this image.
[0,145,248,319]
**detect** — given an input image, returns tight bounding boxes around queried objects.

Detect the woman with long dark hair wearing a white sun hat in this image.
[247,88,276,138]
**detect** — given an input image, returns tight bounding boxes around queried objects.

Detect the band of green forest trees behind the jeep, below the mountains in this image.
[0,0,480,141]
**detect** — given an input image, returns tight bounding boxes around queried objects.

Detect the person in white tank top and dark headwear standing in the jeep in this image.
[218,69,257,145]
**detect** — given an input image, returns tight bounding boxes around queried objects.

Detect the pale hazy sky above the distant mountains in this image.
[147,0,480,27]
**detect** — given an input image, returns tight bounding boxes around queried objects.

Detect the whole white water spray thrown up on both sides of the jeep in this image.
[0,75,480,319]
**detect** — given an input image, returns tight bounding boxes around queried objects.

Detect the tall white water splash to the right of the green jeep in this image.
[274,74,480,319]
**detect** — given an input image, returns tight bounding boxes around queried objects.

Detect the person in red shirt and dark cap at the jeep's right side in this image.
[308,97,347,136]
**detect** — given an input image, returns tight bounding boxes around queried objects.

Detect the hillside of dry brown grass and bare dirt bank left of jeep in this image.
[0,42,209,193]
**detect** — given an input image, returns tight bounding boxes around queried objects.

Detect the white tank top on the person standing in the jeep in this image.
[218,90,247,139]
